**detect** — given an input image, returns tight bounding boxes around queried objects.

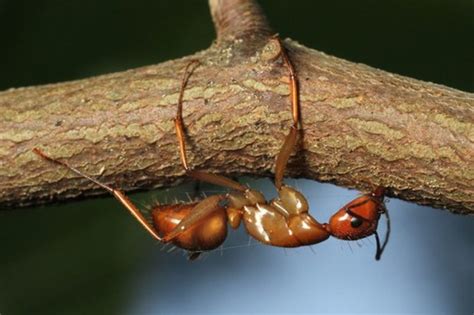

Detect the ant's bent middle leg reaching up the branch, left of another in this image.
[174,60,247,192]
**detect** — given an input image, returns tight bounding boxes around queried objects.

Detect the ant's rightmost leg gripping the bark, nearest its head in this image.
[273,36,300,190]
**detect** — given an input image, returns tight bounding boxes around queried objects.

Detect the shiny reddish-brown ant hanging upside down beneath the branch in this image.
[33,36,390,260]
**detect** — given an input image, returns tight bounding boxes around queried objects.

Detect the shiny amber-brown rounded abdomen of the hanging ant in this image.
[152,202,227,252]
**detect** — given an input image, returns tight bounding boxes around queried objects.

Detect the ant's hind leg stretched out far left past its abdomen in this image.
[33,148,161,241]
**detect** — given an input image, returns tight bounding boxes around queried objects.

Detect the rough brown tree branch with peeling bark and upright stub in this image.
[0,0,474,214]
